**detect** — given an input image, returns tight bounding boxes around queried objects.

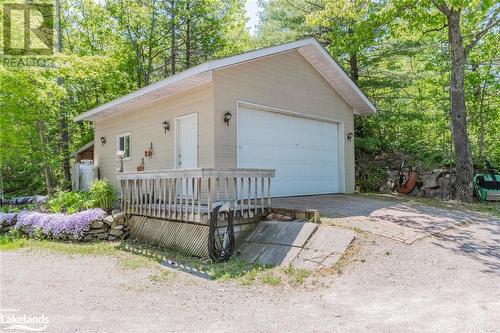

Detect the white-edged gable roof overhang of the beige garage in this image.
[74,38,376,121]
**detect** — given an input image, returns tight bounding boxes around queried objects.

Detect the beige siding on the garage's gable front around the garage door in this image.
[214,51,354,192]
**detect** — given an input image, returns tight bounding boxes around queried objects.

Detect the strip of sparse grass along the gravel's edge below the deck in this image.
[0,234,311,286]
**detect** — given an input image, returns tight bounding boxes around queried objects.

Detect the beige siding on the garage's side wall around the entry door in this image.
[94,84,214,186]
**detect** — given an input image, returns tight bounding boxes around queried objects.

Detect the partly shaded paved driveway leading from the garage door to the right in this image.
[273,194,500,275]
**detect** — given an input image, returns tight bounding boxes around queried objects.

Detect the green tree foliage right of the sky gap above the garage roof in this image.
[256,0,500,190]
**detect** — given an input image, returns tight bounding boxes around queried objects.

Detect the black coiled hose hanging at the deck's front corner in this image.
[208,205,234,262]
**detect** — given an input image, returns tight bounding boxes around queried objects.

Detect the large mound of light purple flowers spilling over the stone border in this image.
[16,208,106,240]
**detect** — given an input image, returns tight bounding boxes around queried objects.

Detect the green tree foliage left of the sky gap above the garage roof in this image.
[0,0,249,196]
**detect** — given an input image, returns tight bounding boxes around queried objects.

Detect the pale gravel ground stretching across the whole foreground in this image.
[0,202,500,332]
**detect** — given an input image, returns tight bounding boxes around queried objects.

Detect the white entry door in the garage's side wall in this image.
[175,113,198,169]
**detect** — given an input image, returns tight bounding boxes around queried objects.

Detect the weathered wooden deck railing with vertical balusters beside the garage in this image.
[117,168,275,223]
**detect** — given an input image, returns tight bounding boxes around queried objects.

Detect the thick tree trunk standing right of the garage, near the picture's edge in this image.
[447,9,474,202]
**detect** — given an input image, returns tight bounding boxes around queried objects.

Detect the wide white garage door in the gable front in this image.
[238,107,339,197]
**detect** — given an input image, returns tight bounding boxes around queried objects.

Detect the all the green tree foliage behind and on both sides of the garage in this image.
[0,0,500,197]
